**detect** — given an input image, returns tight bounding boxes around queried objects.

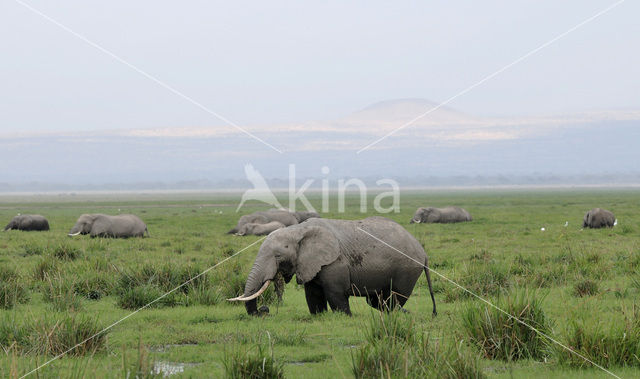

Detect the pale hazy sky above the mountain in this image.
[0,0,640,132]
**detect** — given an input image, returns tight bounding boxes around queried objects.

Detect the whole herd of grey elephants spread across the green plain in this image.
[4,207,616,315]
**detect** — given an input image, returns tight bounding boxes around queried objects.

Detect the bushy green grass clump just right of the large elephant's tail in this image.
[462,292,551,361]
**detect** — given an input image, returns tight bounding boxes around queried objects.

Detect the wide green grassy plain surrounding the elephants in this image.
[0,189,640,378]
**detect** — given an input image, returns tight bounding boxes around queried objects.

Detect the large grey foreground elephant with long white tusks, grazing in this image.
[229,216,436,315]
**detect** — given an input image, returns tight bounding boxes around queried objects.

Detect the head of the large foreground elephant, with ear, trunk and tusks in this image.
[229,223,340,315]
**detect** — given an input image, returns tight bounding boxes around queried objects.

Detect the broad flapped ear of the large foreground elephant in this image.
[296,225,340,283]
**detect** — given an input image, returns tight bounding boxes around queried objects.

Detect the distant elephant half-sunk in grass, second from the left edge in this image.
[69,214,149,238]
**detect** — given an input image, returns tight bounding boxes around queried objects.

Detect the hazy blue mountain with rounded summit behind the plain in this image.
[0,99,640,189]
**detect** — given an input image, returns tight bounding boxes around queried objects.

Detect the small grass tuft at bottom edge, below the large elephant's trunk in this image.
[223,343,284,379]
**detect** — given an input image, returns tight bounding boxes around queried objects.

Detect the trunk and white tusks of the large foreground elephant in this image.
[229,244,278,315]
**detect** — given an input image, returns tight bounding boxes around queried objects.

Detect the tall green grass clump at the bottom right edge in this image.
[556,305,640,367]
